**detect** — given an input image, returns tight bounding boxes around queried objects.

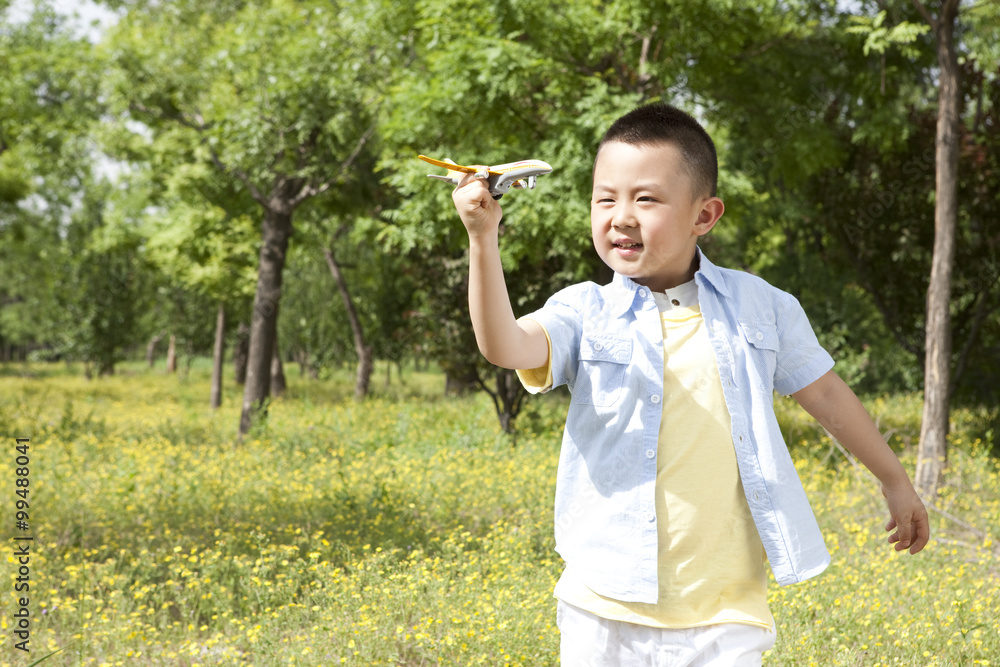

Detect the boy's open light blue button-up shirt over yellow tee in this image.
[526,249,833,603]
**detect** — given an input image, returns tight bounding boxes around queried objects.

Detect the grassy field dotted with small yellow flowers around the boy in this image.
[0,363,1000,667]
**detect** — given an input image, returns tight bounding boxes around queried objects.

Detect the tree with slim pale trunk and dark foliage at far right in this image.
[700,2,997,478]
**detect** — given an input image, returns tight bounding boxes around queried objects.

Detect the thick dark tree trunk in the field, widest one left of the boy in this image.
[239,197,292,438]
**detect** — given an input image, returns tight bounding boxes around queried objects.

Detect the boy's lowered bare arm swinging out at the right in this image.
[792,371,930,554]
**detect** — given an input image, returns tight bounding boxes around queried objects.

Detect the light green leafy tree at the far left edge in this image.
[0,3,118,372]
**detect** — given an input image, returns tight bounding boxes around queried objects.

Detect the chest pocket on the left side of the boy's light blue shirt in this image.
[573,334,632,407]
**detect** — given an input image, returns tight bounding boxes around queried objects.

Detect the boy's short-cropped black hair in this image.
[597,102,719,197]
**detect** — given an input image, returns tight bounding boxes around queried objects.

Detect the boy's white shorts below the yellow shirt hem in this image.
[556,600,776,667]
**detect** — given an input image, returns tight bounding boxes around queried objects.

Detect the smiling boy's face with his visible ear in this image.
[590,141,724,291]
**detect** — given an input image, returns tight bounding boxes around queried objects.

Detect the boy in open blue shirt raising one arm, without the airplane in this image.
[453,104,929,667]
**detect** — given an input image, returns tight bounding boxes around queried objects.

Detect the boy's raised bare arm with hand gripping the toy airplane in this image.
[452,174,549,369]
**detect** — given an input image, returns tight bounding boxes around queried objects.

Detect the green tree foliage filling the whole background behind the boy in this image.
[0,0,1000,422]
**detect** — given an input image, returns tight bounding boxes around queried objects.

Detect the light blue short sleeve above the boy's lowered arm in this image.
[774,293,834,396]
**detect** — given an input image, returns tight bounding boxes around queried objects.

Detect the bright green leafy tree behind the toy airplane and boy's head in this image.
[384,0,840,430]
